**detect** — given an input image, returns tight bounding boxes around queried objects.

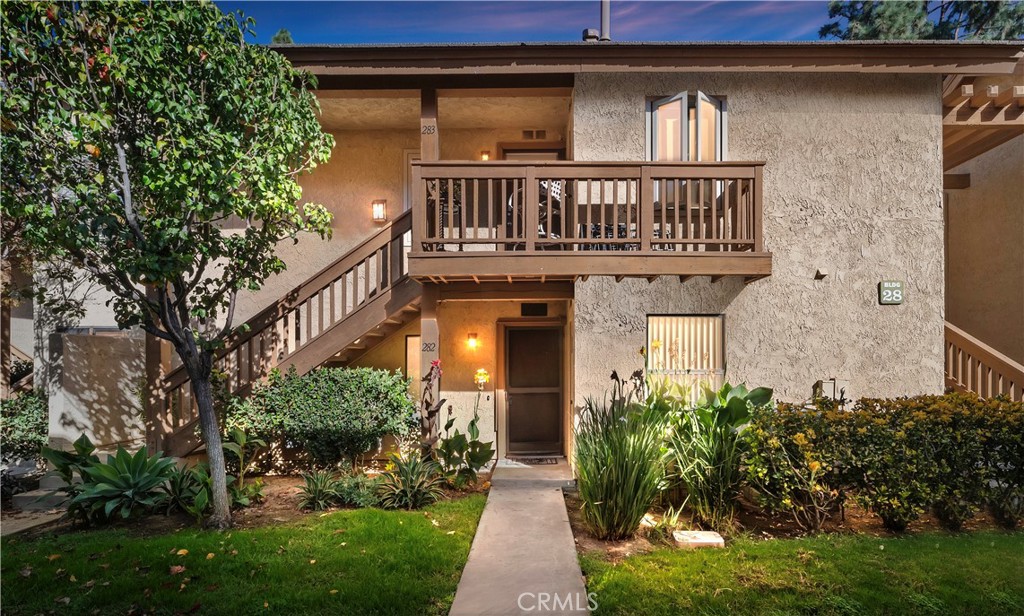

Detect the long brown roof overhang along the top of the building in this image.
[273,41,1024,81]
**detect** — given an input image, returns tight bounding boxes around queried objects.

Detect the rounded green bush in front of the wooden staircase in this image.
[225,368,417,467]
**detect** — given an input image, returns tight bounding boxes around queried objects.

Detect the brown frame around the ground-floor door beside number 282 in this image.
[495,317,568,459]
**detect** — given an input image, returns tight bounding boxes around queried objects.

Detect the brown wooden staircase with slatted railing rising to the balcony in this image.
[155,212,422,456]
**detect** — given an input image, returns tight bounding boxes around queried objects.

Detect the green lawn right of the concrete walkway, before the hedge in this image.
[581,532,1024,616]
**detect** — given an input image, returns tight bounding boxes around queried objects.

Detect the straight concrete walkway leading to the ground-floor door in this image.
[451,460,588,616]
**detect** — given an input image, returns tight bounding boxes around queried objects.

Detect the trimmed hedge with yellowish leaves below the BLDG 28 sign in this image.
[744,393,1024,531]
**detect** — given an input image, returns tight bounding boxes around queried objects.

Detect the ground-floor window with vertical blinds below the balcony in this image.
[647,315,725,397]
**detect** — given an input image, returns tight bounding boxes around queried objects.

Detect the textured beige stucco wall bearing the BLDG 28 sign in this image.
[573,74,943,400]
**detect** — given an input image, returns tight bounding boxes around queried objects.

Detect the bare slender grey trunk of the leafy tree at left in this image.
[185,352,231,530]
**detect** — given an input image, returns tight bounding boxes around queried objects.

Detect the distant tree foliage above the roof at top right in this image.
[818,0,1024,40]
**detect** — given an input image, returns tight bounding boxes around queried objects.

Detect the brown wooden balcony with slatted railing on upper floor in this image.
[409,161,771,282]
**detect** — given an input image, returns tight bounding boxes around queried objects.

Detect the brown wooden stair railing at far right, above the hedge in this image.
[945,322,1024,401]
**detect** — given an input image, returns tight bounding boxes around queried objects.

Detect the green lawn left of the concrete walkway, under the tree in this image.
[0,494,485,615]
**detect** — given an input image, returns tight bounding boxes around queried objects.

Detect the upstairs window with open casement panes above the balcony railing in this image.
[647,92,726,162]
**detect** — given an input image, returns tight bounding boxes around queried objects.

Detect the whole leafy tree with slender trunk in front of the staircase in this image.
[0,0,334,528]
